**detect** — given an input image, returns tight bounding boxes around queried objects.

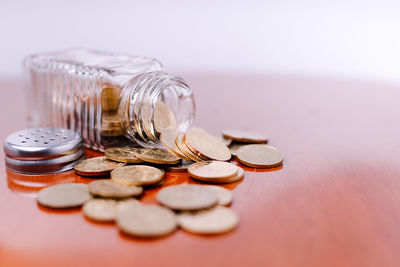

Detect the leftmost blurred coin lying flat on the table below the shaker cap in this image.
[37,183,91,209]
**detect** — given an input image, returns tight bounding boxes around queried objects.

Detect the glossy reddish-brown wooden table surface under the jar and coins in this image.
[0,74,400,267]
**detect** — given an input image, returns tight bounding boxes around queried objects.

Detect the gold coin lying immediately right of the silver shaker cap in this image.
[74,157,125,176]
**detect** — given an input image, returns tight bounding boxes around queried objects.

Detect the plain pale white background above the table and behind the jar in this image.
[0,0,400,83]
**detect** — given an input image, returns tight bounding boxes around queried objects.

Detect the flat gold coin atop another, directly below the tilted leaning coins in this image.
[188,161,238,179]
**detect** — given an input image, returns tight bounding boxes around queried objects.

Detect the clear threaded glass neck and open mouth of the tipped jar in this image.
[119,71,195,147]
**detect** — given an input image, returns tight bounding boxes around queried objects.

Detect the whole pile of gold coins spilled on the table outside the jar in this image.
[37,126,283,237]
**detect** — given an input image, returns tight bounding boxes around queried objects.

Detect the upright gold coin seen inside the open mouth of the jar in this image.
[154,100,177,133]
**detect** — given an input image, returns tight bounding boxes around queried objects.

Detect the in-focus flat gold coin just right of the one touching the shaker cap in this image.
[111,165,165,186]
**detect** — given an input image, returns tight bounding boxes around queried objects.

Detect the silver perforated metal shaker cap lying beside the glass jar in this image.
[4,127,83,174]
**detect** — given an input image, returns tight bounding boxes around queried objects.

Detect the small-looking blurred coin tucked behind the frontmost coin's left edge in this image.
[82,198,118,222]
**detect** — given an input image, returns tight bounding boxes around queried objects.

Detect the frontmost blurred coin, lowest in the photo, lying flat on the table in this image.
[116,202,177,237]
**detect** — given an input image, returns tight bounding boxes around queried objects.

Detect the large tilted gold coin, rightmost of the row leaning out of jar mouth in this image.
[183,128,232,161]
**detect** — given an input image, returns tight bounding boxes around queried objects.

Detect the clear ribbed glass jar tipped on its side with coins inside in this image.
[25,49,195,150]
